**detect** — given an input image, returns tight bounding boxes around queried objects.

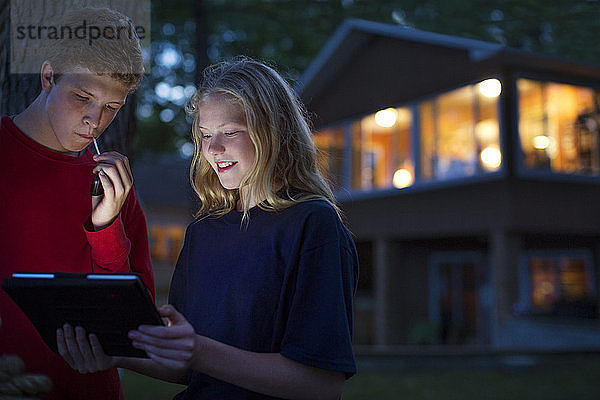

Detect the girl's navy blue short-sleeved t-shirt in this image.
[169,200,358,399]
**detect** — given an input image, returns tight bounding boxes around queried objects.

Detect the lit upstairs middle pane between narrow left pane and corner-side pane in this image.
[352,107,414,190]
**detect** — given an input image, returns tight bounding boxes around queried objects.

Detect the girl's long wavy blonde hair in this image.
[186,58,339,220]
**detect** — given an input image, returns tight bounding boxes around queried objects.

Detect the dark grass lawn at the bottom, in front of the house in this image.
[122,354,600,400]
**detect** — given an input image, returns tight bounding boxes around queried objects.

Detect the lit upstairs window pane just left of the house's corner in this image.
[419,79,502,180]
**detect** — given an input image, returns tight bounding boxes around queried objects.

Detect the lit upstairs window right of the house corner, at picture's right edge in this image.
[517,79,600,175]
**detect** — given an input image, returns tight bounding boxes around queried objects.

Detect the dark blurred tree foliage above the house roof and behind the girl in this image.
[137,0,600,152]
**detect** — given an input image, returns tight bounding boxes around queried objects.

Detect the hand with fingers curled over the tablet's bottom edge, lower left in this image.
[56,324,118,374]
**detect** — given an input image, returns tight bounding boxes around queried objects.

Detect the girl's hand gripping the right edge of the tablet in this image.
[129,305,197,370]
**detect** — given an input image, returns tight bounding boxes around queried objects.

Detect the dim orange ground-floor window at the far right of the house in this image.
[519,250,598,318]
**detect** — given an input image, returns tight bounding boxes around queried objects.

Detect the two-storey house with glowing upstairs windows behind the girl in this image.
[297,20,600,352]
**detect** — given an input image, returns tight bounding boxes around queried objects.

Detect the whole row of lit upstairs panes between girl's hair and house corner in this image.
[314,79,502,192]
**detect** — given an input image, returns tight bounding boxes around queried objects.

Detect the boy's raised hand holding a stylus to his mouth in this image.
[92,151,133,231]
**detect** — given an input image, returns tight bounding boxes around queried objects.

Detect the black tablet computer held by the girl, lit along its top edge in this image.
[2,272,164,357]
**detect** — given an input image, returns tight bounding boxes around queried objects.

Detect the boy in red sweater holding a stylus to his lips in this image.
[0,9,154,400]
